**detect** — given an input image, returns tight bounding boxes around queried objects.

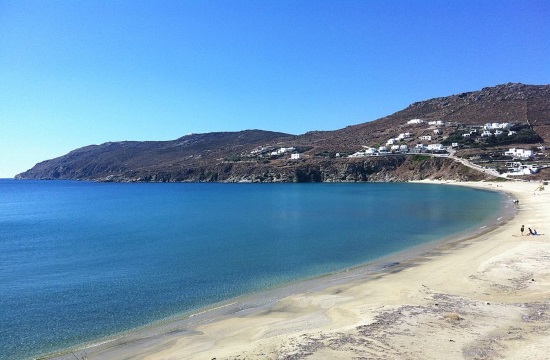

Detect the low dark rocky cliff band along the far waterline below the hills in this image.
[20,155,489,183]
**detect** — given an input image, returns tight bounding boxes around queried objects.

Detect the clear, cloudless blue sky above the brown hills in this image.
[0,0,550,177]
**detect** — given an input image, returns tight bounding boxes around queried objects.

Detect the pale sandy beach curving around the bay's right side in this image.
[62,182,550,359]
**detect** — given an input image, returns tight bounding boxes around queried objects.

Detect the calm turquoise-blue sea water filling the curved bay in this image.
[0,180,503,359]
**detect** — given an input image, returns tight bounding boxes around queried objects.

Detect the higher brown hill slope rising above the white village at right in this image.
[301,83,550,152]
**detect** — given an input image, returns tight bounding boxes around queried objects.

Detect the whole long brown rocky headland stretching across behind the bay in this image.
[17,84,550,182]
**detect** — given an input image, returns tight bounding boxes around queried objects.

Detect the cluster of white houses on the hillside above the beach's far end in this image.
[246,118,550,176]
